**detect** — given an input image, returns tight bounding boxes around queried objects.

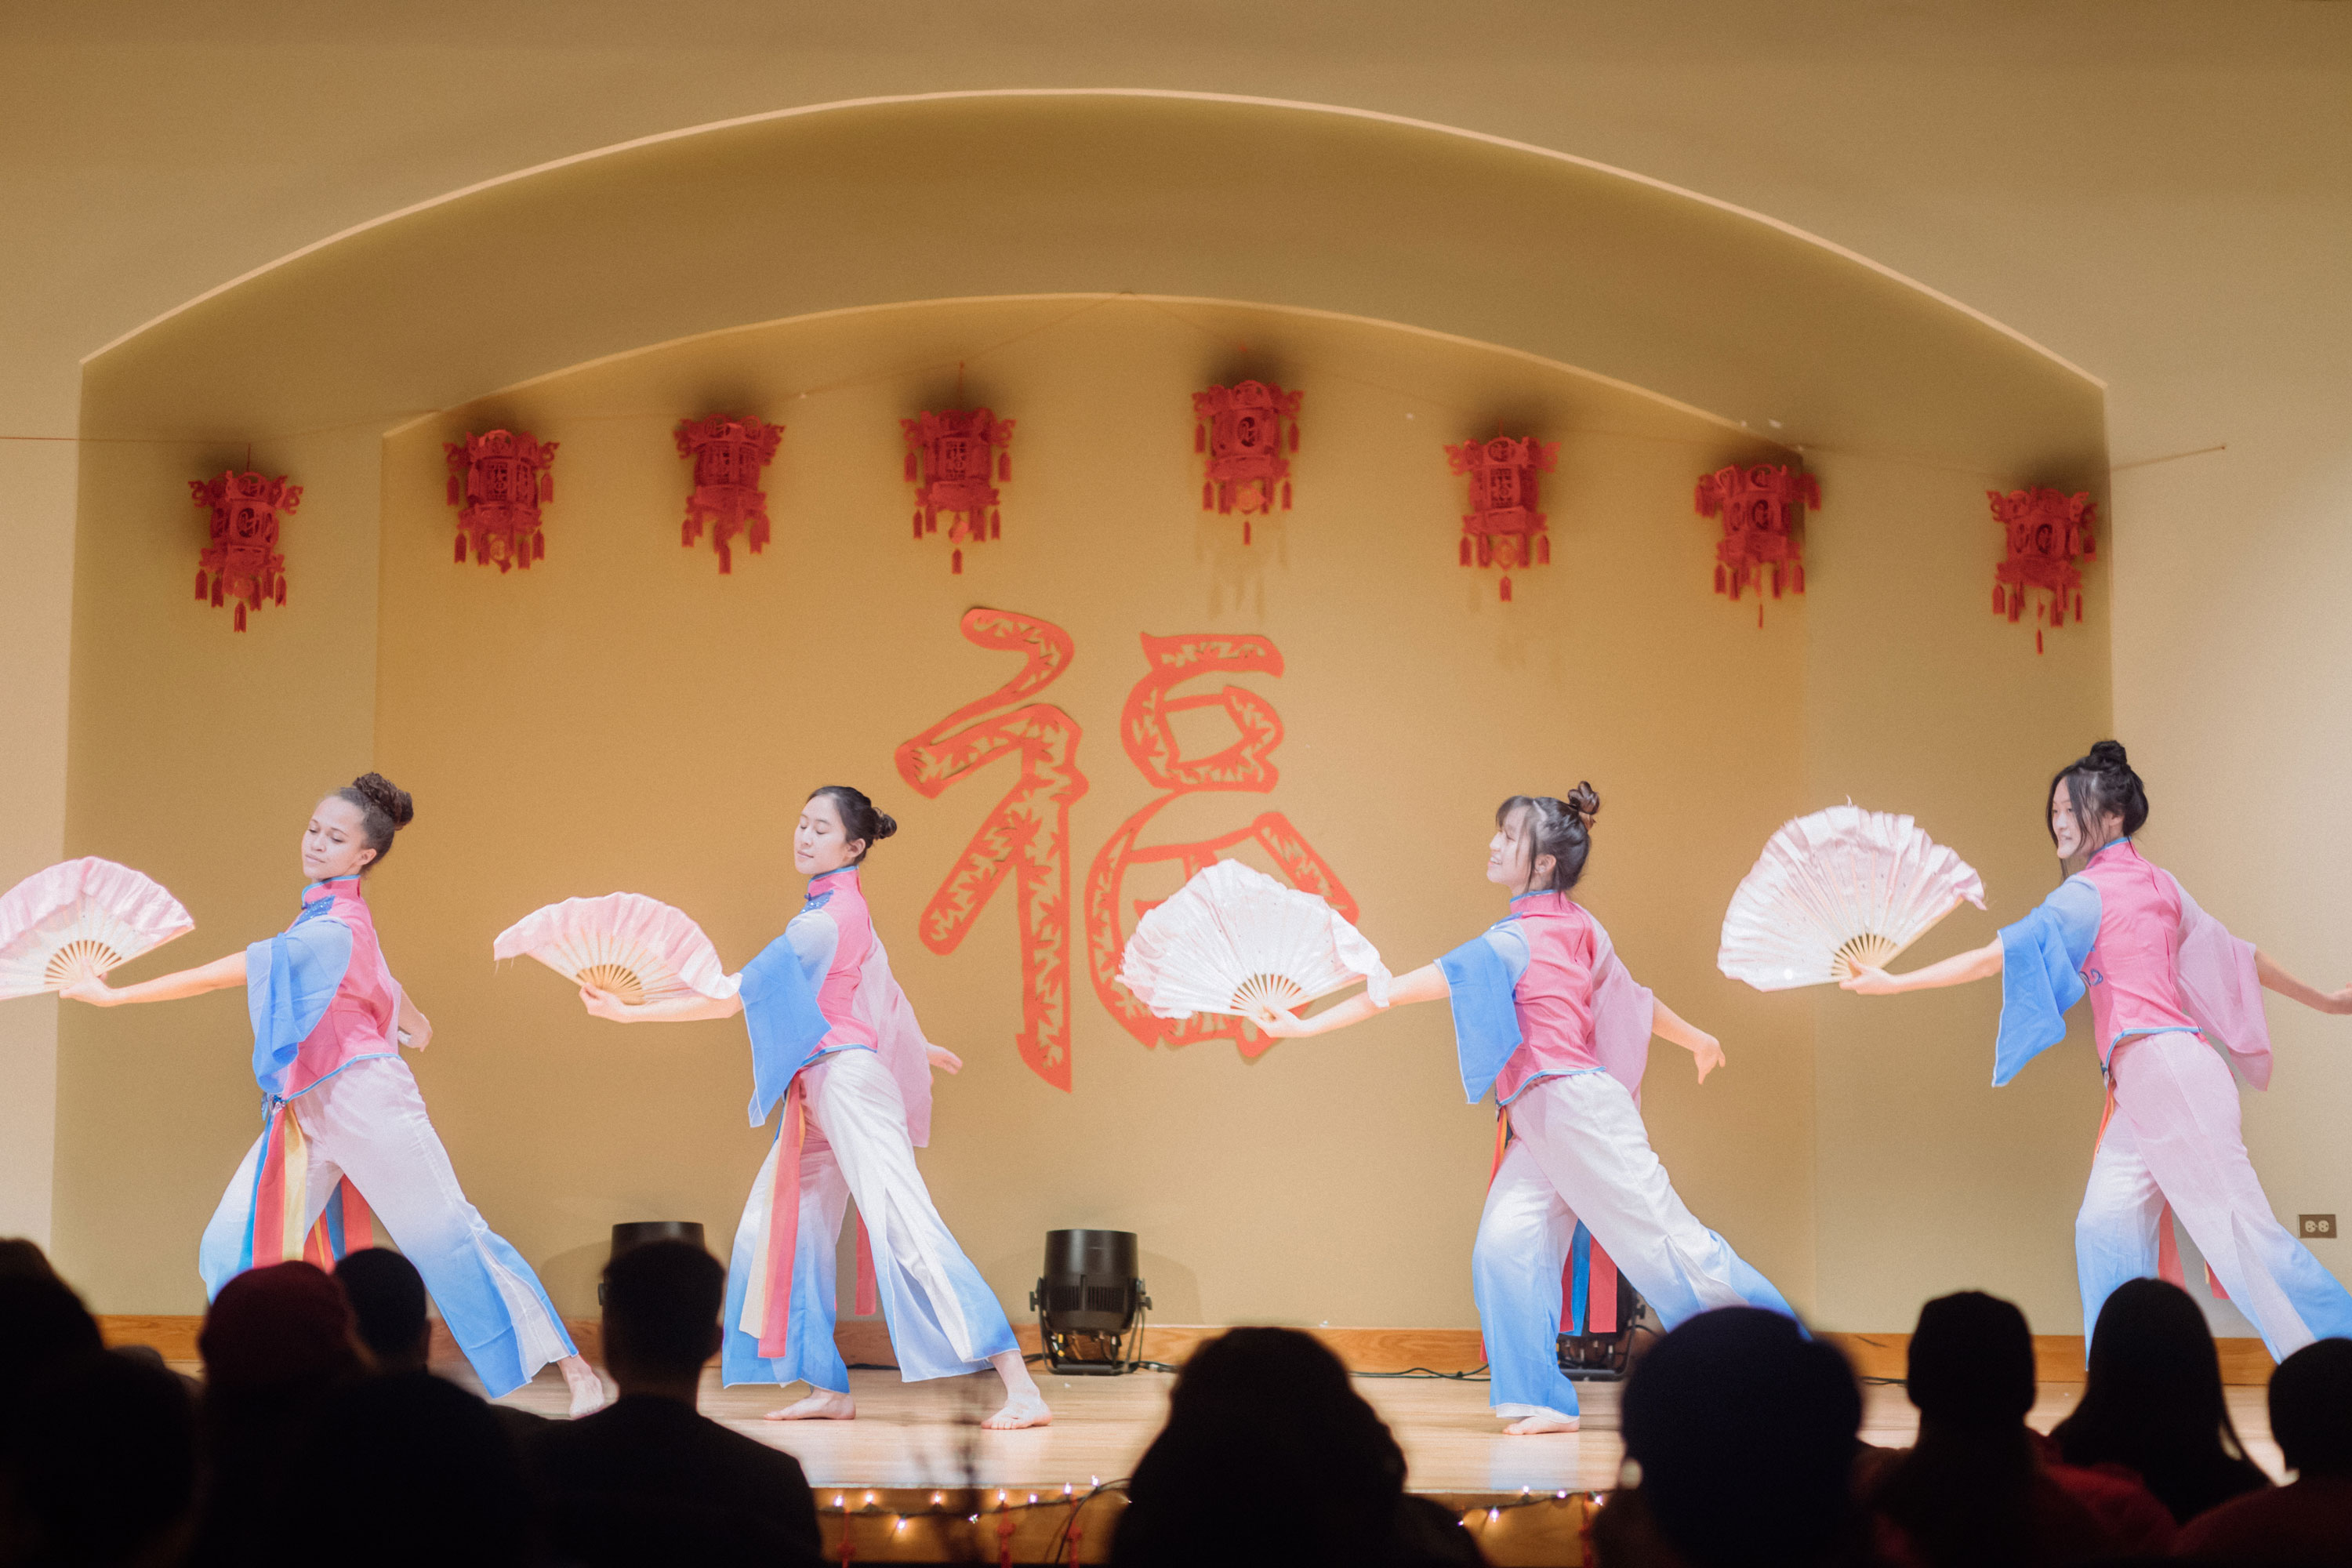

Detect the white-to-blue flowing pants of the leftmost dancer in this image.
[198,1055,574,1399]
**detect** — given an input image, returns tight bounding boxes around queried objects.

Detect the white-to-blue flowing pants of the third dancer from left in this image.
[1470,1072,1795,1417]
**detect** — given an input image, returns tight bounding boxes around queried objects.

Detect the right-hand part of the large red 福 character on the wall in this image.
[1087,633,1355,1060]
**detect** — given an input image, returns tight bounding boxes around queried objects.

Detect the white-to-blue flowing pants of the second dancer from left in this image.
[722,1051,1018,1394]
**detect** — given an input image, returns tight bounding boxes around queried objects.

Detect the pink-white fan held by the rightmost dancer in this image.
[1715,804,1985,992]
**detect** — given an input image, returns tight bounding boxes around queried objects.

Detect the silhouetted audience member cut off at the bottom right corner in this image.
[2178,1340,2352,1568]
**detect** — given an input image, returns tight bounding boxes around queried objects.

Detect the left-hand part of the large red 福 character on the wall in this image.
[898,609,1087,1088]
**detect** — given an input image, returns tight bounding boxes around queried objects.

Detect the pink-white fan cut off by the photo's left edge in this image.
[0,855,195,999]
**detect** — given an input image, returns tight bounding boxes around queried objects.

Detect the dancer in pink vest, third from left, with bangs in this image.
[1254,783,1795,1436]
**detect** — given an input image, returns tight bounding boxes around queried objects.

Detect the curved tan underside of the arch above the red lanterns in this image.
[85,92,2105,482]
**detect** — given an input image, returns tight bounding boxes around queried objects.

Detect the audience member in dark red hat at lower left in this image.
[191,1262,365,1568]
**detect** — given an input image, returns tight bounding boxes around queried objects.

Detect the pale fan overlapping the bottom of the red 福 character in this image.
[1120,860,1388,1018]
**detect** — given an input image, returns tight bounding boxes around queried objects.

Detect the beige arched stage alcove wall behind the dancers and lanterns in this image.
[56,99,2107,1330]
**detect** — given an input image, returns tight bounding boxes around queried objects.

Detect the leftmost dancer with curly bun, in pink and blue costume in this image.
[64,774,604,1415]
